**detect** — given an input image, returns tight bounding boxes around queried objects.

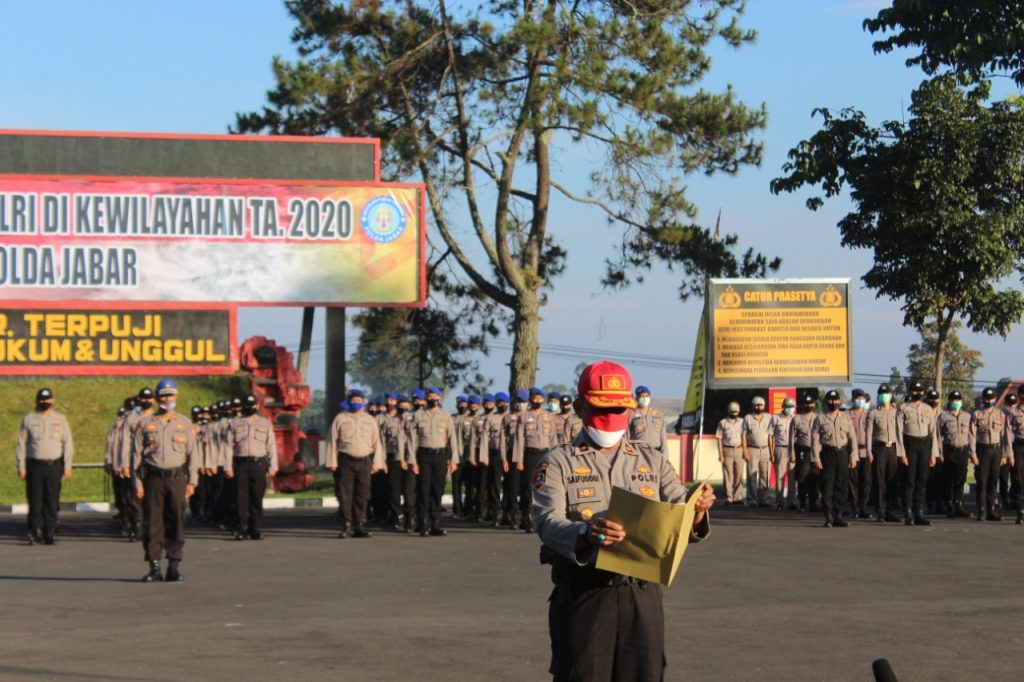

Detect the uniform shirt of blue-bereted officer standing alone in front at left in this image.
[131,405,199,486]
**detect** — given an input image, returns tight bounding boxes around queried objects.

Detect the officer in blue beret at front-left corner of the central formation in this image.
[327,389,387,538]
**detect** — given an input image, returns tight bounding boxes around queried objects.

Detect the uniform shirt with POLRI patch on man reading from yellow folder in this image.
[530,436,710,566]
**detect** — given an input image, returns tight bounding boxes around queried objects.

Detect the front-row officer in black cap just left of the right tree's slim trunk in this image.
[899,381,937,525]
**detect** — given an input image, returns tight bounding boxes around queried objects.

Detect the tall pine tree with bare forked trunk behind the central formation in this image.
[236,0,778,386]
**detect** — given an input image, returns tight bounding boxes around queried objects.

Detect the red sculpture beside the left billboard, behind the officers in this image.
[239,336,317,493]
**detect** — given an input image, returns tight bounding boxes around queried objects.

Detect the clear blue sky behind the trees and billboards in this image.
[0,0,1024,395]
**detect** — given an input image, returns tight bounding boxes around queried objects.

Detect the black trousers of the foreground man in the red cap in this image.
[548,583,666,682]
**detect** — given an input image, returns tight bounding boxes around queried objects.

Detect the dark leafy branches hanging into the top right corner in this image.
[864,0,1024,86]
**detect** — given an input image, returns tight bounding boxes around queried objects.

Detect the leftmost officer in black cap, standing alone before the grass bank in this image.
[14,388,75,545]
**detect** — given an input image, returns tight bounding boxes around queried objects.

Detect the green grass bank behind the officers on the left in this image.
[0,374,249,505]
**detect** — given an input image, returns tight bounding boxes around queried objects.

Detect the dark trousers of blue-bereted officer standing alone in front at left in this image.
[142,471,188,561]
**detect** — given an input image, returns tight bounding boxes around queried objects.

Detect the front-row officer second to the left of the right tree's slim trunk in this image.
[867,384,906,523]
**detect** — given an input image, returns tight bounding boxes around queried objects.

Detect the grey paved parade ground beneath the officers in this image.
[0,509,1024,682]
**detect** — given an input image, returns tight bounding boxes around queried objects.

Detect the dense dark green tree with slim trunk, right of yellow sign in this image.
[771,76,1024,390]
